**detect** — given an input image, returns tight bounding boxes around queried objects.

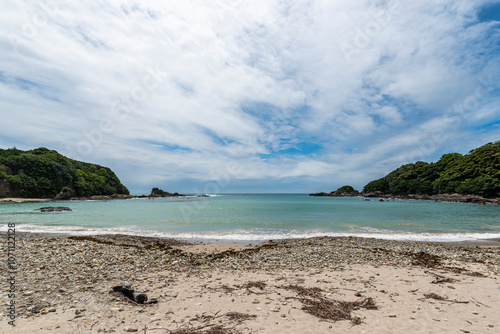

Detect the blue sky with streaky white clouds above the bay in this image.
[0,0,500,193]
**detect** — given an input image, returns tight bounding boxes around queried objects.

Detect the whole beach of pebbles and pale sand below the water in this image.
[0,234,500,334]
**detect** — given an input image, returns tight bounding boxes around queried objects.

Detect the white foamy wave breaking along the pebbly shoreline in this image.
[0,224,500,242]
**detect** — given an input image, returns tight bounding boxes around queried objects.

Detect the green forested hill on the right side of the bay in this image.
[363,141,500,198]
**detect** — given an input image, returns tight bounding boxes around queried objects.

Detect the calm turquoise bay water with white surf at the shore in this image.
[0,194,500,241]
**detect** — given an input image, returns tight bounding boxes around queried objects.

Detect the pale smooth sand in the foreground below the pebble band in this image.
[0,265,500,334]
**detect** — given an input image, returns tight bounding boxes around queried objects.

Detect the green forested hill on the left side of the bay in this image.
[0,147,129,199]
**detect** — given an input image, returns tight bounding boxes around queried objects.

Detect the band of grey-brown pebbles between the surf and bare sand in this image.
[8,235,500,317]
